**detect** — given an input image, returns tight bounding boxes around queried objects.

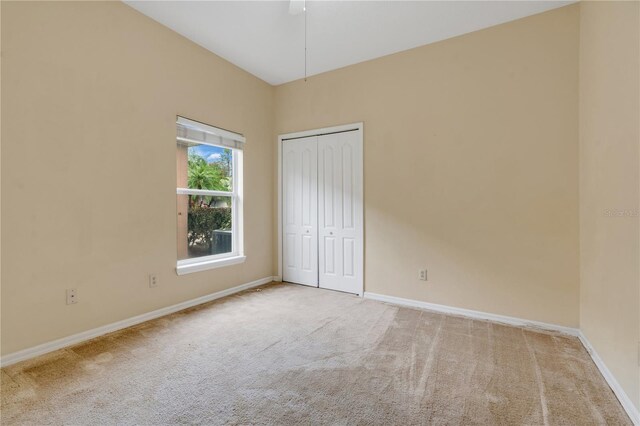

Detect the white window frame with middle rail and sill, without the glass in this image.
[176,124,246,275]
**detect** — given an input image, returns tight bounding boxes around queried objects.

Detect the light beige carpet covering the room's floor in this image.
[1,284,631,425]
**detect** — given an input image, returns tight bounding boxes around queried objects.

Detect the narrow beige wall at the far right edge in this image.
[580,2,640,409]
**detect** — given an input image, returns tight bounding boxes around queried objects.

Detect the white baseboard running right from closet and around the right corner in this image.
[364,291,640,426]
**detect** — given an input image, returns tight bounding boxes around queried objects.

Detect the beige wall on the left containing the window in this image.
[2,1,275,354]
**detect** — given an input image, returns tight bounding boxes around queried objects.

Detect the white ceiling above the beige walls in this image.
[125,0,573,85]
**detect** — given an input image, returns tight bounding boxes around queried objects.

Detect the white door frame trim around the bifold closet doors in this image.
[274,121,365,297]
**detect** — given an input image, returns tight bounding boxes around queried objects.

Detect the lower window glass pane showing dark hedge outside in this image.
[178,195,233,260]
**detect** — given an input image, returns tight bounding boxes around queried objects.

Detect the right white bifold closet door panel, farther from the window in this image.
[318,131,362,294]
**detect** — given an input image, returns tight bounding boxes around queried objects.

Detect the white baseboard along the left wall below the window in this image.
[0,277,274,367]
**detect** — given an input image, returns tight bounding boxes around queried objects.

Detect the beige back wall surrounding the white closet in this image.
[276,5,579,327]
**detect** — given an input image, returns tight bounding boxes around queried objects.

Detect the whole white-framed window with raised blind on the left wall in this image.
[176,117,245,275]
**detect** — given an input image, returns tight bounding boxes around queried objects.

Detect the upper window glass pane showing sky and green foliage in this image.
[177,141,233,191]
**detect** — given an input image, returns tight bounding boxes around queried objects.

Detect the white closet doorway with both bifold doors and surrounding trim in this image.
[278,123,364,295]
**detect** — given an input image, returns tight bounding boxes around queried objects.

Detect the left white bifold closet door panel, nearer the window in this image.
[282,136,318,287]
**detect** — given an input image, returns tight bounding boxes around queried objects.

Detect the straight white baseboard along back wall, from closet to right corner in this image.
[364,291,579,337]
